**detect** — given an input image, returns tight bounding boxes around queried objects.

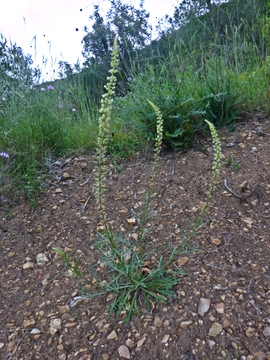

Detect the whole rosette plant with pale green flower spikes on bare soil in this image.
[54,40,221,322]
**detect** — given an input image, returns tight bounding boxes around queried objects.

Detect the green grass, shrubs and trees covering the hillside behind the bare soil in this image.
[0,0,270,202]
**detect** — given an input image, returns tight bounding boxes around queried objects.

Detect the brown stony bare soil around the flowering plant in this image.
[0,116,270,360]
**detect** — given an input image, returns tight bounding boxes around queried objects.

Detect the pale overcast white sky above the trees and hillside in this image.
[0,0,177,80]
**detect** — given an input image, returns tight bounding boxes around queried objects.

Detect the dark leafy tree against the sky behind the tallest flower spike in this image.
[82,0,152,71]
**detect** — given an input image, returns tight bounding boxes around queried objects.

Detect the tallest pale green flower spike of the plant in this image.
[94,37,119,230]
